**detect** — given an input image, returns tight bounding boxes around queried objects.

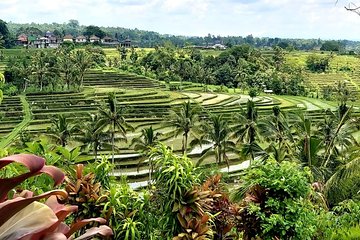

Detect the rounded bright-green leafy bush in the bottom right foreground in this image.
[234,159,316,239]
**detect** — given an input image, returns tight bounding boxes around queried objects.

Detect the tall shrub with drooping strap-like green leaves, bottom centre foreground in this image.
[150,144,199,239]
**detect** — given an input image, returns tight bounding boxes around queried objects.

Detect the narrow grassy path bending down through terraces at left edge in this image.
[0,95,31,148]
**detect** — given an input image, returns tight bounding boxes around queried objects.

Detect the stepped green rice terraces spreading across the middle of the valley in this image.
[0,68,358,186]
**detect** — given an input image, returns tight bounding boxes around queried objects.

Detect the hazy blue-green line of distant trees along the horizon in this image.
[7,20,360,51]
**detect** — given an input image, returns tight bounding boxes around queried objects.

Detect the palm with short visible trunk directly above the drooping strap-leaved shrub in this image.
[164,101,201,154]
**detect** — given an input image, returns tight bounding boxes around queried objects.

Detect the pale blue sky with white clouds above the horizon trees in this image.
[0,0,360,40]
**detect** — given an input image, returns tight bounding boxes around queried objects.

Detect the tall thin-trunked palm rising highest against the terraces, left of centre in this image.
[98,93,133,167]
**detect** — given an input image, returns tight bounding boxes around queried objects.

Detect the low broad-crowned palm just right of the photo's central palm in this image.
[190,115,237,166]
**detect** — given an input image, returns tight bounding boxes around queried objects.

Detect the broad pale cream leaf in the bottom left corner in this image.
[0,202,58,240]
